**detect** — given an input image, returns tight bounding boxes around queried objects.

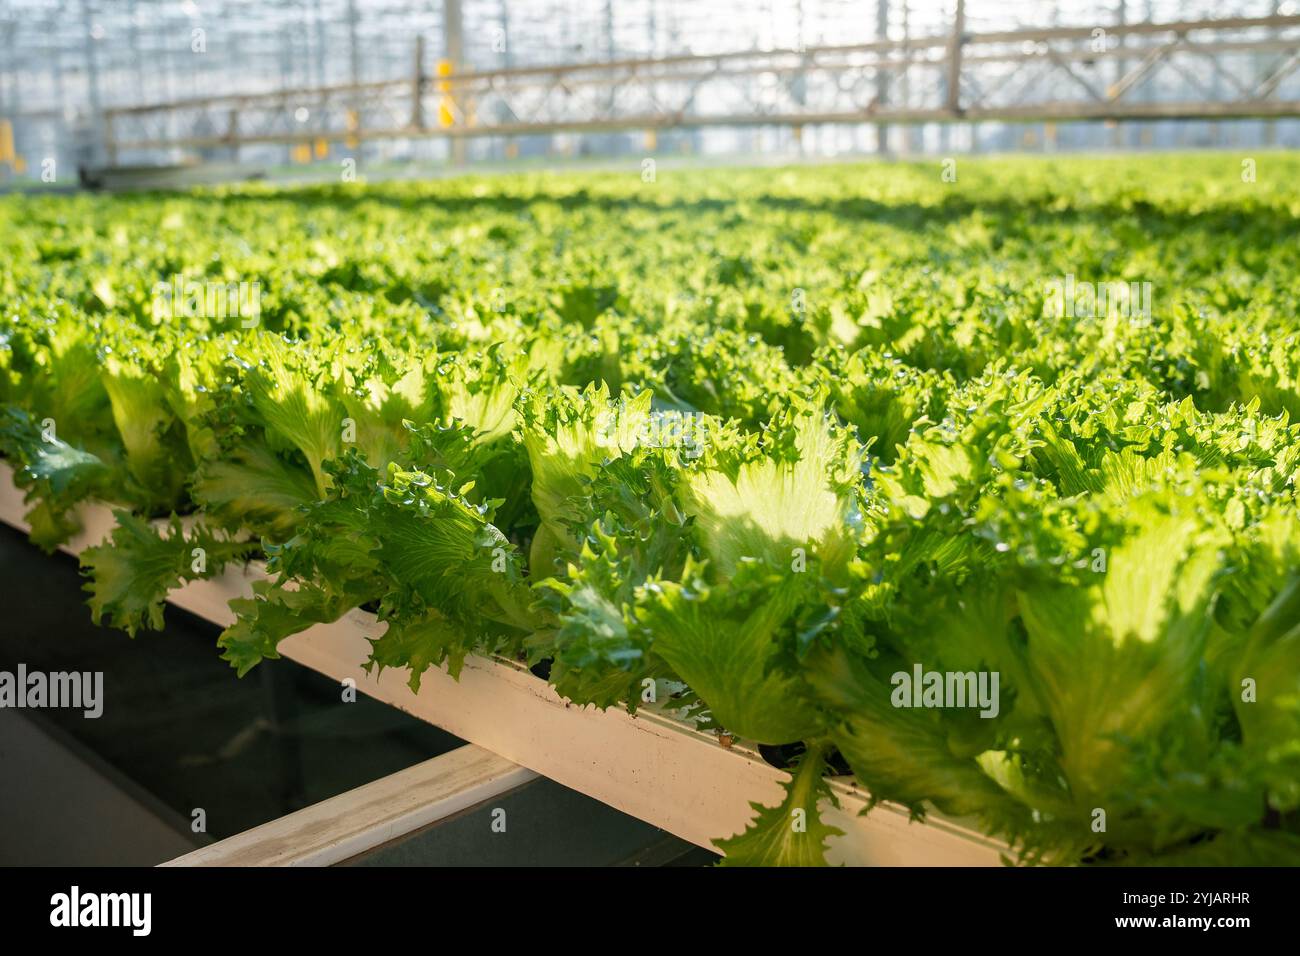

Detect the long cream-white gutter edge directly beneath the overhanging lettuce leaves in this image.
[0,462,1006,866]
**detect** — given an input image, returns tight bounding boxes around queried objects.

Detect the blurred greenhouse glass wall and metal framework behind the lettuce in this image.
[0,0,1300,183]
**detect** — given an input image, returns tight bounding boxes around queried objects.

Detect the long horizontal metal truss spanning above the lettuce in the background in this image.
[105,3,1300,157]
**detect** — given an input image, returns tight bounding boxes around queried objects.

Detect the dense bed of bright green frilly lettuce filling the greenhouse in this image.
[0,157,1300,864]
